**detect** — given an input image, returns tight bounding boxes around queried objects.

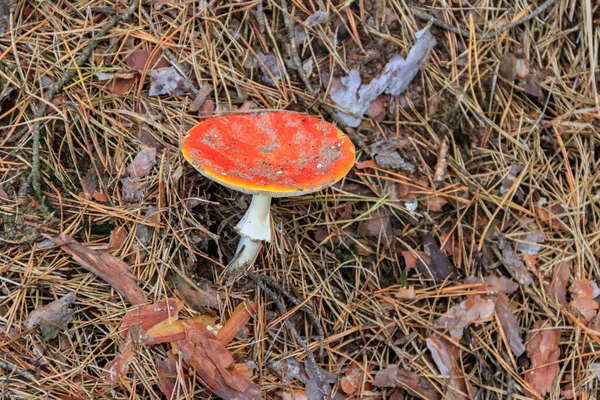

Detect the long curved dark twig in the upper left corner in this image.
[25,0,139,200]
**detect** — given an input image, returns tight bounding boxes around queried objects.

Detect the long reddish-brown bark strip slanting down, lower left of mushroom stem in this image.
[49,235,146,304]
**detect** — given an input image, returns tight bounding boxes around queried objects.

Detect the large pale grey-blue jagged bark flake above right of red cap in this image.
[330,27,436,127]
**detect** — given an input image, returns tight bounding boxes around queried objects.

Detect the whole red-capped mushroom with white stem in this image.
[181,111,354,276]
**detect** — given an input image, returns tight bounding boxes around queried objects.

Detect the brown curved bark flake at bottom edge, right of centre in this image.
[373,365,441,400]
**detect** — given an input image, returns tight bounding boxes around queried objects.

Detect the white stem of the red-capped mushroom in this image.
[227,195,271,275]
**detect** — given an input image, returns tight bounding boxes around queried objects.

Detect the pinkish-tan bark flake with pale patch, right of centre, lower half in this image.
[435,295,495,339]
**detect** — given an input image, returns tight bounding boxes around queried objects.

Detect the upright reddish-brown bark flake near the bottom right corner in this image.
[524,321,560,397]
